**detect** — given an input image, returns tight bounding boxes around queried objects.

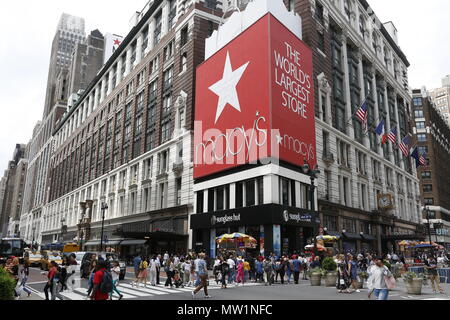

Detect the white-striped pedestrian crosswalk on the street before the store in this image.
[27,282,260,301]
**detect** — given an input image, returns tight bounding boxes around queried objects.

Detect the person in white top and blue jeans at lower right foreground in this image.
[367,257,393,300]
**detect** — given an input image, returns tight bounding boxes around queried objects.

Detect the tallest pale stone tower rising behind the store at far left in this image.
[44,13,85,119]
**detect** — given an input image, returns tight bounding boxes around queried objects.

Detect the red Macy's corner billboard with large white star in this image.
[194,13,317,179]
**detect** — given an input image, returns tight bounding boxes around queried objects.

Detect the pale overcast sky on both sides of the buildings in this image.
[0,0,450,175]
